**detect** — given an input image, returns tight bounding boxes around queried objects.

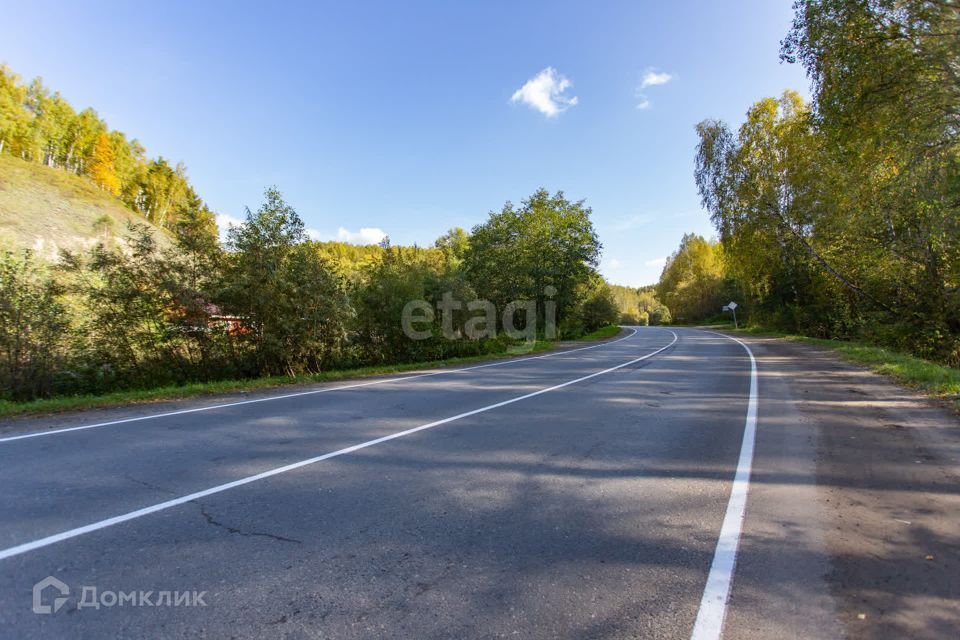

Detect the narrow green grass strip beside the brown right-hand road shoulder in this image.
[725,327,960,411]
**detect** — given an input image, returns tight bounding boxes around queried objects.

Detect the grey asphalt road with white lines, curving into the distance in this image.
[0,328,955,639]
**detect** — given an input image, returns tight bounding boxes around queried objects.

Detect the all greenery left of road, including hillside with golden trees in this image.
[0,67,618,413]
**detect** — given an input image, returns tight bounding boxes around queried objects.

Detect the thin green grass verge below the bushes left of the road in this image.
[0,327,600,418]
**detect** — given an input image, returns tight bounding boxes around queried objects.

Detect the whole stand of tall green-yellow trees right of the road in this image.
[656,0,960,367]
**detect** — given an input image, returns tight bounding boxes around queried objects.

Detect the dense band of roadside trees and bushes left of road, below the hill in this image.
[0,180,618,400]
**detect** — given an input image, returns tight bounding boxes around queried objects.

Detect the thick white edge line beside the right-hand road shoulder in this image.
[690,331,758,640]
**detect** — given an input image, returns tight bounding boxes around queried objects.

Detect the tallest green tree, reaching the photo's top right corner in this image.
[781,0,960,362]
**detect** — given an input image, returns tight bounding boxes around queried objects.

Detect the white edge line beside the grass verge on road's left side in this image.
[0,329,637,444]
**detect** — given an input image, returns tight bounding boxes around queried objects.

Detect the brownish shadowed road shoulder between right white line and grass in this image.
[726,337,960,638]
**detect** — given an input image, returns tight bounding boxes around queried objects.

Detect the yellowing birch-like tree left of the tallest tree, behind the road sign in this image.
[696,92,872,334]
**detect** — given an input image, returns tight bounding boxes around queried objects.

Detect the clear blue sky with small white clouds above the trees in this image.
[0,0,808,285]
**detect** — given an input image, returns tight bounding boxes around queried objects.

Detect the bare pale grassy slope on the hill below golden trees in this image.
[0,156,166,260]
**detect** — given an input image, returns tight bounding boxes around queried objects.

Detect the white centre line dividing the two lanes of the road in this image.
[0,329,677,560]
